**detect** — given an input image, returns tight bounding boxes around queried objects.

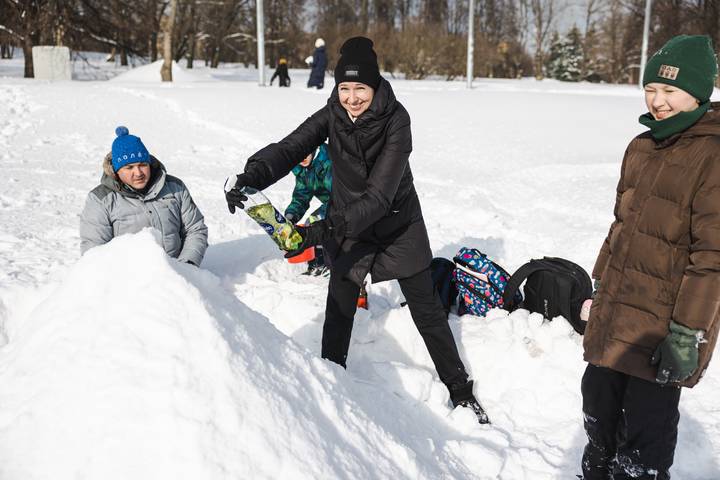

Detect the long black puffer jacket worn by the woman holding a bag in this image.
[245,79,432,283]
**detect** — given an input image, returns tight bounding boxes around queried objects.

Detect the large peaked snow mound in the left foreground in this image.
[0,231,444,480]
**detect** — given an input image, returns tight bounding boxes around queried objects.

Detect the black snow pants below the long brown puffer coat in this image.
[581,364,680,480]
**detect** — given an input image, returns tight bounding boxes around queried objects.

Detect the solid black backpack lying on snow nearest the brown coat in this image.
[503,257,592,335]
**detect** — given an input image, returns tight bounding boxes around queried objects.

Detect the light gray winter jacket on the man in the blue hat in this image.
[80,155,207,265]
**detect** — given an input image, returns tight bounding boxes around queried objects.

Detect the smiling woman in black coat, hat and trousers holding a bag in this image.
[227,37,488,423]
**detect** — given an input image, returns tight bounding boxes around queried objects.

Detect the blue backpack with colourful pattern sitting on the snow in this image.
[453,247,522,317]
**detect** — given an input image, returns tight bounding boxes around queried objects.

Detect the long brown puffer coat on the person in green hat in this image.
[584,103,720,387]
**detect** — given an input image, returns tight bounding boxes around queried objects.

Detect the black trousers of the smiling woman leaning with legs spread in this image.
[322,268,468,387]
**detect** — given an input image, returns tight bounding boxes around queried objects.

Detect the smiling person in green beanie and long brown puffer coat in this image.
[582,35,720,480]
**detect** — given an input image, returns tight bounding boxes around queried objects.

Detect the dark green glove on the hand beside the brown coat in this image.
[650,320,704,384]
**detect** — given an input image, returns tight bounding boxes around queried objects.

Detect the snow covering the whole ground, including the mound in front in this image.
[0,54,720,480]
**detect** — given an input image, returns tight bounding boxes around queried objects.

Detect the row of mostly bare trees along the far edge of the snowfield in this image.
[0,0,720,83]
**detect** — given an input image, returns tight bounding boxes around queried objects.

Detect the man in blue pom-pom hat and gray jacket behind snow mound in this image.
[80,127,207,266]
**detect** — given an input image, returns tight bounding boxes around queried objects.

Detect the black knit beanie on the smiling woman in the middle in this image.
[335,37,380,90]
